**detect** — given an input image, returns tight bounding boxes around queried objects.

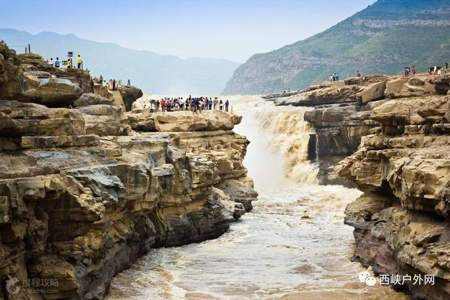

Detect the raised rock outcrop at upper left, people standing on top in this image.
[0,41,142,110]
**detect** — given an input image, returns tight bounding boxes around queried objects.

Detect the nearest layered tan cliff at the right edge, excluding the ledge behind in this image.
[338,95,450,300]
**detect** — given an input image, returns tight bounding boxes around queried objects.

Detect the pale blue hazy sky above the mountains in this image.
[0,0,375,62]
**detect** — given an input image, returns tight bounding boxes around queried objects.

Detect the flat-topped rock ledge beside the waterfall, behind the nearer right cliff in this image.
[274,74,450,159]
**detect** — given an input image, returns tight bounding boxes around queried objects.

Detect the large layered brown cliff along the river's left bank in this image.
[0,45,257,299]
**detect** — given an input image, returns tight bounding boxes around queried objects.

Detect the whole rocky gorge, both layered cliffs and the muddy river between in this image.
[0,33,450,300]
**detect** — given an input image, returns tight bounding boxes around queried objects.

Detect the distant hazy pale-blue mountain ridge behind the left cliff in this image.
[0,29,238,95]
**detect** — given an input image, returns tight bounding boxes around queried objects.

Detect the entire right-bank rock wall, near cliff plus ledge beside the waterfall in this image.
[274,74,450,300]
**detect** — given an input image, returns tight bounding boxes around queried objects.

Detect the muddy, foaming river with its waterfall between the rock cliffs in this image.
[108,98,406,300]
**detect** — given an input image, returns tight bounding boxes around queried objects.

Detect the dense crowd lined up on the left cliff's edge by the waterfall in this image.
[145,96,232,113]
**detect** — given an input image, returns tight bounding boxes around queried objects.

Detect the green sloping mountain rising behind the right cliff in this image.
[223,0,450,94]
